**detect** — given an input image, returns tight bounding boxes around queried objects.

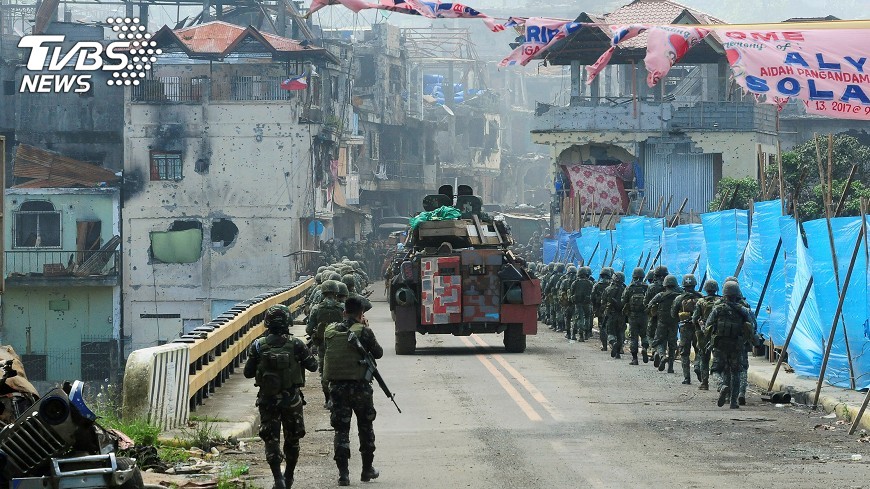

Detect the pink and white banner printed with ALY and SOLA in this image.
[713,28,870,120]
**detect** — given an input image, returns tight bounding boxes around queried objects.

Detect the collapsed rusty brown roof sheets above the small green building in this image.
[12,144,118,188]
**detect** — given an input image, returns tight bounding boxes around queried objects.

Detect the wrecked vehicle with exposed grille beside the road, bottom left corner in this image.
[0,347,144,489]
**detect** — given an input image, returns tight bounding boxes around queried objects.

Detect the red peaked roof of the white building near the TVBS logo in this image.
[154,20,337,62]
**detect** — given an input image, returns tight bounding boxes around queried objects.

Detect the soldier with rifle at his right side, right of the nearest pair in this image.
[323,298,384,486]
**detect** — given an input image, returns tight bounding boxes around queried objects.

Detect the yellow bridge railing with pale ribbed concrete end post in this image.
[122,279,314,429]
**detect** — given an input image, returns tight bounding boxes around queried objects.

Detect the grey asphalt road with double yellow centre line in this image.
[240,293,870,489]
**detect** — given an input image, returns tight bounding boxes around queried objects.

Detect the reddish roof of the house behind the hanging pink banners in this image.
[604,0,724,49]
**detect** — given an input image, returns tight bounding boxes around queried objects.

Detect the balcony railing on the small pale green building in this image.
[6,250,121,282]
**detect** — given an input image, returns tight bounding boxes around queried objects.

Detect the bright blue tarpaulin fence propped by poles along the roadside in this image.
[544,200,870,389]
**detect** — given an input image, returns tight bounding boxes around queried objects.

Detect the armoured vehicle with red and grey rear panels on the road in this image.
[389,185,541,355]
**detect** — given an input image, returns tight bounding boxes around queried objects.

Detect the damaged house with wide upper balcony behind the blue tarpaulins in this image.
[532,0,777,217]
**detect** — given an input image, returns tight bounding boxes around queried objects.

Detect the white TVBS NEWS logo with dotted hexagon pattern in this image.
[18,17,162,93]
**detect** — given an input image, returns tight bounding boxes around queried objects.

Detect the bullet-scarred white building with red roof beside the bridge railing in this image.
[123,21,338,349]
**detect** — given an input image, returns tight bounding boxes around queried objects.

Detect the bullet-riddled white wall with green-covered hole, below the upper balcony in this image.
[123,100,320,349]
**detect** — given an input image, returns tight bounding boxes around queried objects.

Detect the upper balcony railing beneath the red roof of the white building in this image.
[131,75,305,103]
